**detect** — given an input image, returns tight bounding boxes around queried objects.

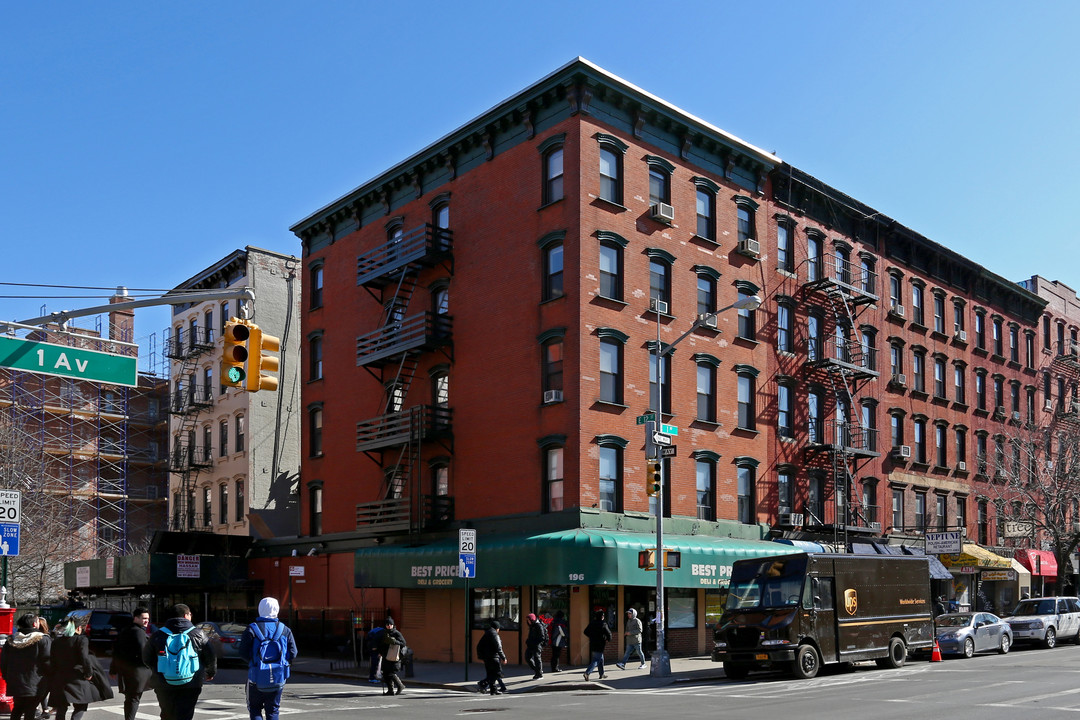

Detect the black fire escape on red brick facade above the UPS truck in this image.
[802,250,880,545]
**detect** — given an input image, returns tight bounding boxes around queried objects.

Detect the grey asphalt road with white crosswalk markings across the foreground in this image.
[78,644,1080,720]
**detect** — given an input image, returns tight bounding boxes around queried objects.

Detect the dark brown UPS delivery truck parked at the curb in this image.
[713,553,934,679]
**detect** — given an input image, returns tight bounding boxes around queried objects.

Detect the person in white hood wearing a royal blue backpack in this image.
[240,598,297,720]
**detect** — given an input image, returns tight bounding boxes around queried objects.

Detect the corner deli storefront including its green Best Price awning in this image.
[355,528,793,666]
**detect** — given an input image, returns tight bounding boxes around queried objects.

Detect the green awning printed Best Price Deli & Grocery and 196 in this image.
[355,528,798,588]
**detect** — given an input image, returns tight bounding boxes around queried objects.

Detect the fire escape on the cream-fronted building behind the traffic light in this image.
[165,327,214,530]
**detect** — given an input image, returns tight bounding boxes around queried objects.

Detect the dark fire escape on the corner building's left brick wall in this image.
[356,223,454,535]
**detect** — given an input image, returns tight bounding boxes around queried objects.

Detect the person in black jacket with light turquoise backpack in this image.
[143,602,217,720]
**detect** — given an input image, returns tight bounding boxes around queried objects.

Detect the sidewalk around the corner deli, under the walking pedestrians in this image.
[293,655,725,692]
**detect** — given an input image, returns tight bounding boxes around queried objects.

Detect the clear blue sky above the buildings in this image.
[0,0,1080,369]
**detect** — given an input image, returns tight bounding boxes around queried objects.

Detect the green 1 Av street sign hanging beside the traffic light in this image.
[0,336,138,388]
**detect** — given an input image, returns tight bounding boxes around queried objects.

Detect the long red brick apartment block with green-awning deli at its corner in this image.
[249,58,1071,662]
